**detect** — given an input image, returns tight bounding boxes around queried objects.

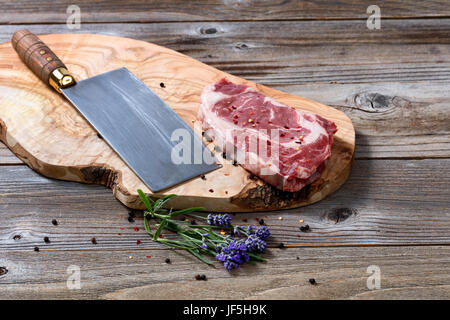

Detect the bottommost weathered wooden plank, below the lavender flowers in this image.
[0,246,450,299]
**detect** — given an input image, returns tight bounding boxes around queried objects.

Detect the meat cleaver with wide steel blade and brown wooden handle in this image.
[11,30,221,192]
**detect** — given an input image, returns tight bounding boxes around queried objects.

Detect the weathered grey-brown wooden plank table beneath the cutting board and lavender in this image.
[0,0,450,299]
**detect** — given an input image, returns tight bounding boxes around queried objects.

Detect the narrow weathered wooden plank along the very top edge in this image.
[0,0,450,23]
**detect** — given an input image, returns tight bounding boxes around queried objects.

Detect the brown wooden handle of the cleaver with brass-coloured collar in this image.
[11,29,75,92]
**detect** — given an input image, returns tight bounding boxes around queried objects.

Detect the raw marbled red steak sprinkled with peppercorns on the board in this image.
[198,79,337,192]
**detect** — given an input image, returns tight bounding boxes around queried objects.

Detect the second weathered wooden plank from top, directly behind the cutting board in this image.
[0,19,450,85]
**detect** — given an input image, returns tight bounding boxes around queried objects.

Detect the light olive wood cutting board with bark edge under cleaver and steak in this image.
[0,34,355,212]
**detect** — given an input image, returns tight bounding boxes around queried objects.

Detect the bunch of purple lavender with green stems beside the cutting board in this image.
[138,190,270,271]
